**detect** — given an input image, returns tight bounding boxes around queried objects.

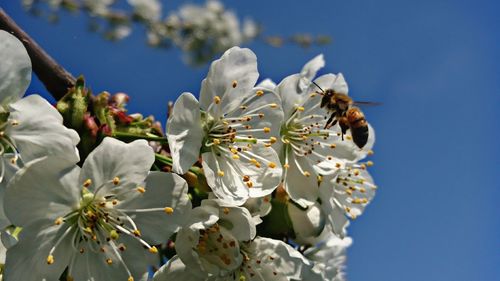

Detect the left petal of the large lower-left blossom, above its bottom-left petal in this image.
[4,157,81,227]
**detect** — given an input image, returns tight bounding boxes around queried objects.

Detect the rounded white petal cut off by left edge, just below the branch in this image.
[0,30,31,105]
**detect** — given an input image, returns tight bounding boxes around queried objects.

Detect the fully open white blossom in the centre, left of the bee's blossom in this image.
[167,47,283,205]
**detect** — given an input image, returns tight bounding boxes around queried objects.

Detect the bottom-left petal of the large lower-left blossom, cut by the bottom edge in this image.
[4,222,75,281]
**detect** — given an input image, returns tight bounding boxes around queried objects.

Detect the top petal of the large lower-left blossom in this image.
[79,137,154,194]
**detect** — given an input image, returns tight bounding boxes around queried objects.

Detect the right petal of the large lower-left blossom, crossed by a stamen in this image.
[116,172,191,244]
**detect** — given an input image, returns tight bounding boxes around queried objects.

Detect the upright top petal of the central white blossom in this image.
[200,47,259,118]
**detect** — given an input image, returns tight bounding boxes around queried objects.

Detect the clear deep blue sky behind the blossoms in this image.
[2,0,500,281]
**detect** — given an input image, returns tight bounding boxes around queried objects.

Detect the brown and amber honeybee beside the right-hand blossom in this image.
[313,81,377,148]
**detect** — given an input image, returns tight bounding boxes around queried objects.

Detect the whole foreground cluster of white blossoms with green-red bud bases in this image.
[0,26,376,281]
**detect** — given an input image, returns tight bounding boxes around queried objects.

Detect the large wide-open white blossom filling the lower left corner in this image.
[4,138,191,281]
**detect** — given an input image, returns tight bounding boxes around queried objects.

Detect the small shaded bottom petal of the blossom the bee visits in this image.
[283,152,318,207]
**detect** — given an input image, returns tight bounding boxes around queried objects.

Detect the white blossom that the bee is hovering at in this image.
[274,55,374,207]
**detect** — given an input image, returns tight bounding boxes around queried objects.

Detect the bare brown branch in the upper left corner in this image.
[0,8,76,100]
